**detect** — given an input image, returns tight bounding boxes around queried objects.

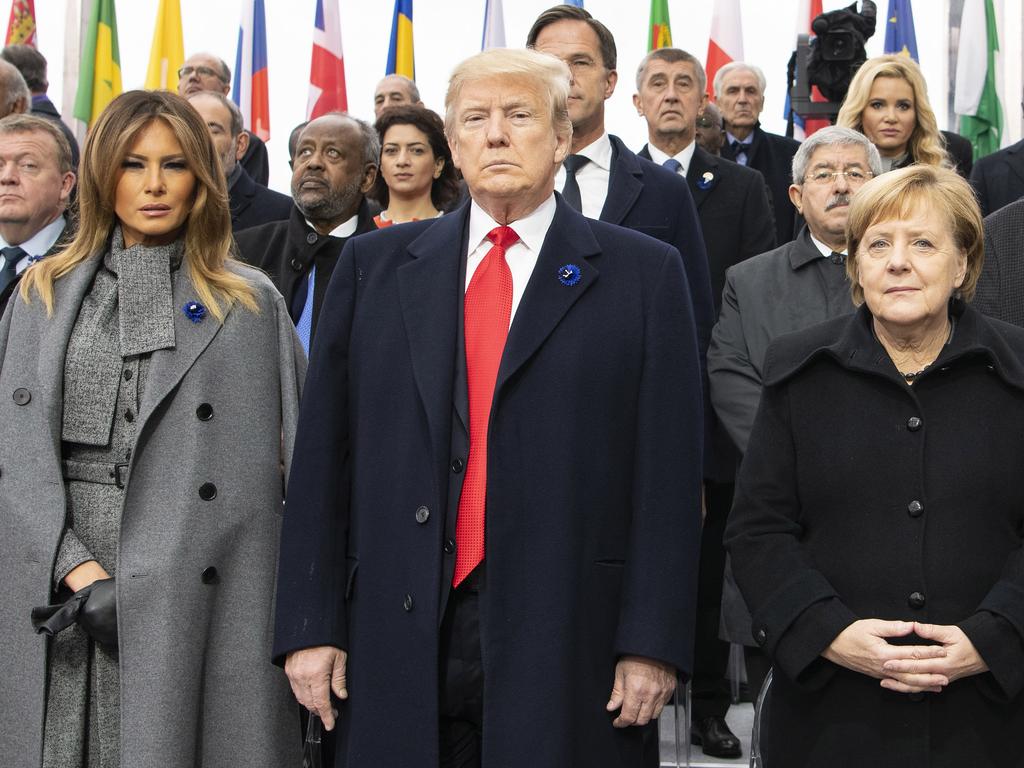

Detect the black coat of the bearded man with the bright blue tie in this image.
[234,200,377,341]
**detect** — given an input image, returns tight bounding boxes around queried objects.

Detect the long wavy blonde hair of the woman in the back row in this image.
[836,54,951,168]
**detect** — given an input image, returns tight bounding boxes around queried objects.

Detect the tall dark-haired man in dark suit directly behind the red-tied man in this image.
[526,5,715,359]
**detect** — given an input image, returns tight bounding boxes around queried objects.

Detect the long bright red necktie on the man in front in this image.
[452,226,519,587]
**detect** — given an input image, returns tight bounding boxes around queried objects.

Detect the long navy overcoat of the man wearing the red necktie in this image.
[273,200,700,768]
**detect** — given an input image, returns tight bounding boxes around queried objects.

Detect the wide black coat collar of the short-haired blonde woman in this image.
[765,299,1024,390]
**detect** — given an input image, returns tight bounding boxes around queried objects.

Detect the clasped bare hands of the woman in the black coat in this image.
[821,618,988,693]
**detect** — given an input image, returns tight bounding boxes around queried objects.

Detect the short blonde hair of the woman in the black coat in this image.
[846,165,985,306]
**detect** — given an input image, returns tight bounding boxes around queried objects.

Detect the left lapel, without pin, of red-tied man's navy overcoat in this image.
[396,205,469,475]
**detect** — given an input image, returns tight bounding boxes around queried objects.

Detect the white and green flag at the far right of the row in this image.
[953,0,1002,160]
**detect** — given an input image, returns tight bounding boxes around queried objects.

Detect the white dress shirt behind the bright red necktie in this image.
[466,194,557,327]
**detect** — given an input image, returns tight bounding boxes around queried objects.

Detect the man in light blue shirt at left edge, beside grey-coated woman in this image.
[0,115,75,310]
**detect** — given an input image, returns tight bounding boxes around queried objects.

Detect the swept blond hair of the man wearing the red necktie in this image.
[444,48,572,142]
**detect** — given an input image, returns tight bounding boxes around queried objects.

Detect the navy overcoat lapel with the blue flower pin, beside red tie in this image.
[495,199,601,399]
